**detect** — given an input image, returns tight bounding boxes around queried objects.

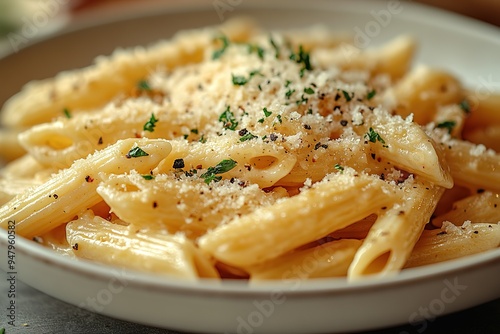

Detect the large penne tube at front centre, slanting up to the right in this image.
[199,170,401,267]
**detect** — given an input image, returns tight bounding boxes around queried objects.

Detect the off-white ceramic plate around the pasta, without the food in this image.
[0,1,500,333]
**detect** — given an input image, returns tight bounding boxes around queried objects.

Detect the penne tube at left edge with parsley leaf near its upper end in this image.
[0,139,171,238]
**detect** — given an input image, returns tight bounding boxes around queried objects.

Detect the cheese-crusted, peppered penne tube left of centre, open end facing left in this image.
[97,172,288,239]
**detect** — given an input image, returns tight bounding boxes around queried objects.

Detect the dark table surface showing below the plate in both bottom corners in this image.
[0,271,500,334]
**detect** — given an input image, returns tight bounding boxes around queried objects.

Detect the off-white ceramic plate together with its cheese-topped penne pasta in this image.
[0,1,500,333]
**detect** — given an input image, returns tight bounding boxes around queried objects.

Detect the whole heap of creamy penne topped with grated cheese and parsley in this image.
[0,19,500,282]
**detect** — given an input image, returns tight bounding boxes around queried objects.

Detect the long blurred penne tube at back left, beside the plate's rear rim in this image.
[0,20,255,128]
